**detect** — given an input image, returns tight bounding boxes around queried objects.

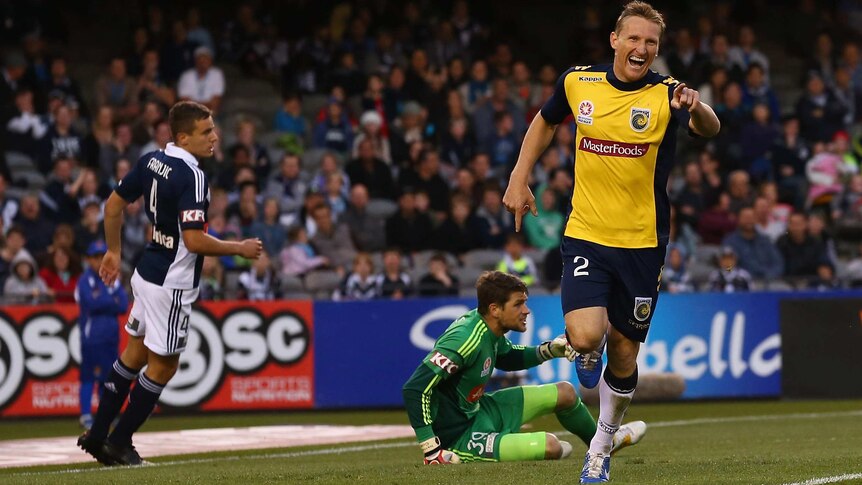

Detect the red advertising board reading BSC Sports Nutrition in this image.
[0,301,314,417]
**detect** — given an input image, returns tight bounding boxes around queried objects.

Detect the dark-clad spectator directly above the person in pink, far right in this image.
[796,71,846,143]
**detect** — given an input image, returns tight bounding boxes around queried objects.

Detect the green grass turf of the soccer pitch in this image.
[0,401,862,485]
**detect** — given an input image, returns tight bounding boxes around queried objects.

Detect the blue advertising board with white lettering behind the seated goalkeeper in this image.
[314,293,787,408]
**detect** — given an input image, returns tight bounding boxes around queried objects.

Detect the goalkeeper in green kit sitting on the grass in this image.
[403,271,646,464]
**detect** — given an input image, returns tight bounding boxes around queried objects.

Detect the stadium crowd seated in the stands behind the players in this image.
[0,0,862,303]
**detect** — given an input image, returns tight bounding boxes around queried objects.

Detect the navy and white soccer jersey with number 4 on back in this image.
[116,143,210,289]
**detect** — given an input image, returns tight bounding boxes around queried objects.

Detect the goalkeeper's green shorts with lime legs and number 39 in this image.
[449,384,557,462]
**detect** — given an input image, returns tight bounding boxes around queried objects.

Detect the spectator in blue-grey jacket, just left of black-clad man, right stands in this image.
[722,207,784,280]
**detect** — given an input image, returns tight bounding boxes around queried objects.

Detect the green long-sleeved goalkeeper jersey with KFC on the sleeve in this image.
[403,310,542,447]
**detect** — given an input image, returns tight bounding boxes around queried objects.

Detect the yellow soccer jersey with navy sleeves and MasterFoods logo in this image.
[541,64,689,248]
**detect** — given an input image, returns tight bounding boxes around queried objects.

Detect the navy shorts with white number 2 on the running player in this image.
[560,236,666,342]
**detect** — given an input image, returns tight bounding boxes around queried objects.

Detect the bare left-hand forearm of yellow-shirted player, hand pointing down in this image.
[503,111,557,231]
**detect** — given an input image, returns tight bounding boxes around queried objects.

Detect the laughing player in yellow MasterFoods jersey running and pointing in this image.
[503,1,720,483]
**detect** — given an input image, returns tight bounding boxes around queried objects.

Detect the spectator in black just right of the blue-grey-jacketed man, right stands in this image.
[776,212,829,279]
